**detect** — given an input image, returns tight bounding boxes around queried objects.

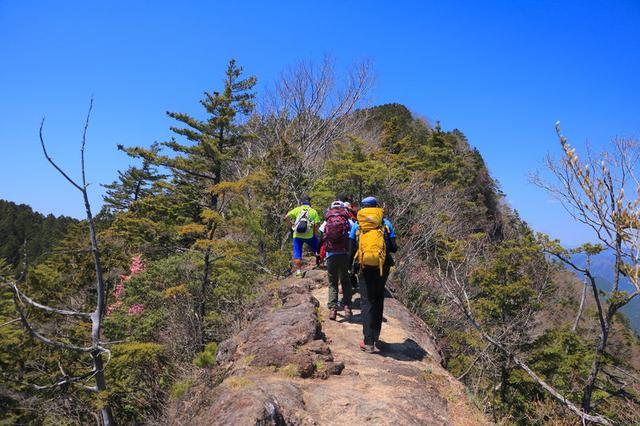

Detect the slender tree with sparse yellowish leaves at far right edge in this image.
[534,122,640,413]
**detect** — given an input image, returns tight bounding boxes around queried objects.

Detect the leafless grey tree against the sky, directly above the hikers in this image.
[246,57,373,199]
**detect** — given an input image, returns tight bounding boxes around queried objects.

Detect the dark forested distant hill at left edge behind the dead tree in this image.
[0,200,78,267]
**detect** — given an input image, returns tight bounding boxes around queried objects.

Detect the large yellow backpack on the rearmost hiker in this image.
[356,207,387,276]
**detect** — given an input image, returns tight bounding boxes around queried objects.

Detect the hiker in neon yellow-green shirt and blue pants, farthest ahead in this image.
[284,195,320,278]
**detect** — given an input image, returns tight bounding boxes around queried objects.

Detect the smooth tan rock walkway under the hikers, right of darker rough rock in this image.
[304,272,484,425]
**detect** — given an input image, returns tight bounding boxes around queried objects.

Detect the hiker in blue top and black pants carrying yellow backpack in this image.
[349,197,398,353]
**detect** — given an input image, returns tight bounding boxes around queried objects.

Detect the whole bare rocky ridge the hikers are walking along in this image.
[165,270,489,425]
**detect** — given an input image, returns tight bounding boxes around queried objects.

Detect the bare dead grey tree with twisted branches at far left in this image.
[3,98,115,426]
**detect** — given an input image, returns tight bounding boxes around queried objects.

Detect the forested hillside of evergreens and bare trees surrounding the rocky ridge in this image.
[0,61,640,424]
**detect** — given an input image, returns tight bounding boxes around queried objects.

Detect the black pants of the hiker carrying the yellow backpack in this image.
[358,268,389,345]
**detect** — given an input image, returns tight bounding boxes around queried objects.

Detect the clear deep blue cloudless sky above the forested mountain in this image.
[0,0,640,244]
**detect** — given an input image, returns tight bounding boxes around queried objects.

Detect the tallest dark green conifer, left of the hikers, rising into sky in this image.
[121,60,256,348]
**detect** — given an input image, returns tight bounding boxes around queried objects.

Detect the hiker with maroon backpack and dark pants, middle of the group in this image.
[319,200,355,321]
